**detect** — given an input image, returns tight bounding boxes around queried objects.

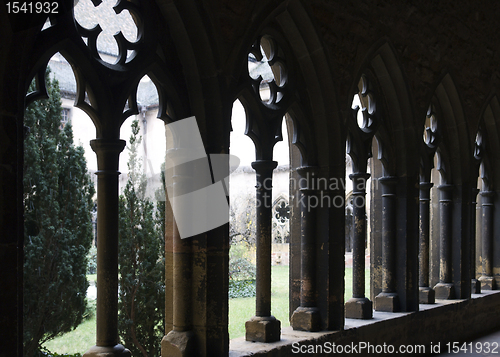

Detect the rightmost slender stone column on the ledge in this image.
[479,191,496,290]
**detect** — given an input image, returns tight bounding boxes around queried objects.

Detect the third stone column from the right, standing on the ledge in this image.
[434,185,455,300]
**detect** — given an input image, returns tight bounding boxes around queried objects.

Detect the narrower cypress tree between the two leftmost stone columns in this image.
[118,120,165,357]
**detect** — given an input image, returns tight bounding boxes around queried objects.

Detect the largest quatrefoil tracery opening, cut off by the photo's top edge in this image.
[75,0,142,65]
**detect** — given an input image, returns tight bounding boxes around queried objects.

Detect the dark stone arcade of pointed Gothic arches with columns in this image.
[0,0,500,356]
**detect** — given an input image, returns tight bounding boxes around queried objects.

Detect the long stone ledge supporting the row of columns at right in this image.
[229,291,500,357]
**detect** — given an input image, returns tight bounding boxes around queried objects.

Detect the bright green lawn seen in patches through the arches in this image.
[45,266,370,354]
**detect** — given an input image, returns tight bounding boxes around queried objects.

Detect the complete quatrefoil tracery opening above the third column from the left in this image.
[248,35,288,107]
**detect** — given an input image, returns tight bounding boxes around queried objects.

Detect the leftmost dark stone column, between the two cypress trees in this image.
[84,139,130,357]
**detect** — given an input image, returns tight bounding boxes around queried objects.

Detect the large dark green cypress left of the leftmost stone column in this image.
[23,71,94,356]
